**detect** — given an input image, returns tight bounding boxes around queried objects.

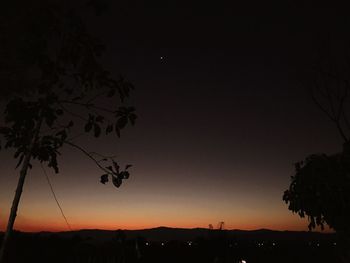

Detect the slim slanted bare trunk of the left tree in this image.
[0,118,42,263]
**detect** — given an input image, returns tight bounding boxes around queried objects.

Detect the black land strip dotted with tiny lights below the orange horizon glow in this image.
[0,229,342,263]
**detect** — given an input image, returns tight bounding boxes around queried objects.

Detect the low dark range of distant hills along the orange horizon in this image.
[28,227,335,242]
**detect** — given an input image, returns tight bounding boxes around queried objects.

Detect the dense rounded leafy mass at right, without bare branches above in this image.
[283,150,350,236]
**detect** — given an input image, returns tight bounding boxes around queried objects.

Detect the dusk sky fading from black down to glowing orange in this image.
[0,1,343,231]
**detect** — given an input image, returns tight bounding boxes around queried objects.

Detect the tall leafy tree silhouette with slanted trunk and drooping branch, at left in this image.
[0,0,136,262]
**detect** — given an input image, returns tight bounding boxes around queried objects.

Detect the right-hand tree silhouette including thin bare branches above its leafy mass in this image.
[283,41,350,262]
